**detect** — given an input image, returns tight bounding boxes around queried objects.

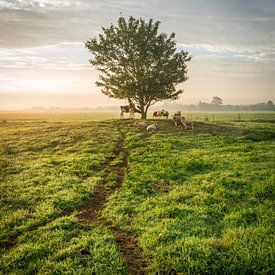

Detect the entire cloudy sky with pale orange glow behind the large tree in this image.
[0,0,275,110]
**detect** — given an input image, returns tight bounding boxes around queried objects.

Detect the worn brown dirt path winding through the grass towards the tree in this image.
[78,128,146,275]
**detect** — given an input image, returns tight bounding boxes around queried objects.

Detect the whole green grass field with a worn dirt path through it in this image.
[0,113,275,274]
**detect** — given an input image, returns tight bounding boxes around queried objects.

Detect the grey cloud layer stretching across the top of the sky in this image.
[0,0,275,47]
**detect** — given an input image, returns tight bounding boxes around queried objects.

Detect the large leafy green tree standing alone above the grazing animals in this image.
[85,17,191,118]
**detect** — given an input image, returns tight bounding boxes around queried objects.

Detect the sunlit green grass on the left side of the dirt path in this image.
[0,121,125,274]
